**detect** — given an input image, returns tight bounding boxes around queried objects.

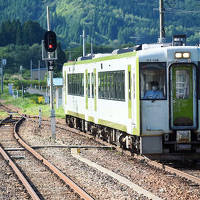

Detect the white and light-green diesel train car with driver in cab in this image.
[63,35,200,160]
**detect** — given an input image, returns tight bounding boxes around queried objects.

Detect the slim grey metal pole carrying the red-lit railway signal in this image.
[47,6,56,140]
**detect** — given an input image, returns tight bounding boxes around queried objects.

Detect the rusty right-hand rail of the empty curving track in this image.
[14,118,94,200]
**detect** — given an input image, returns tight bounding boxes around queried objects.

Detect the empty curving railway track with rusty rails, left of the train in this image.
[0,109,93,199]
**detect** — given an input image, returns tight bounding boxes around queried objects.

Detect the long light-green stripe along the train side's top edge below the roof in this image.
[64,52,137,67]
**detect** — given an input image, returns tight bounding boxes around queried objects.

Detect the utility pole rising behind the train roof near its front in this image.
[158,0,165,43]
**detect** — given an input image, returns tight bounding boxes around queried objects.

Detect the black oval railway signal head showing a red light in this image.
[44,31,57,52]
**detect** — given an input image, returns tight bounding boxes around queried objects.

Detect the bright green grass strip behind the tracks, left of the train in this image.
[0,89,65,119]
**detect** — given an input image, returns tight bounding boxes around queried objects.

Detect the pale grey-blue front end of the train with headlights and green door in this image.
[138,46,200,160]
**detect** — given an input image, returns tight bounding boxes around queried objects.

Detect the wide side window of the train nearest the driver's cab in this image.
[98,70,125,101]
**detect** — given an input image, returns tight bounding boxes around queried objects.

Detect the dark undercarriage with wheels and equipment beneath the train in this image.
[66,115,200,161]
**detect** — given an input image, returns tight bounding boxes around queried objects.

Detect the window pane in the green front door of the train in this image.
[176,70,190,99]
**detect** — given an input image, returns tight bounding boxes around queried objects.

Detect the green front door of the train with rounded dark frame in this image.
[170,63,197,130]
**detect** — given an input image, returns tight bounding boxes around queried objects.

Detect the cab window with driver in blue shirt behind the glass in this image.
[140,63,166,100]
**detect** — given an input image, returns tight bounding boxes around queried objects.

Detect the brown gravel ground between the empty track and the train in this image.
[20,120,200,200]
